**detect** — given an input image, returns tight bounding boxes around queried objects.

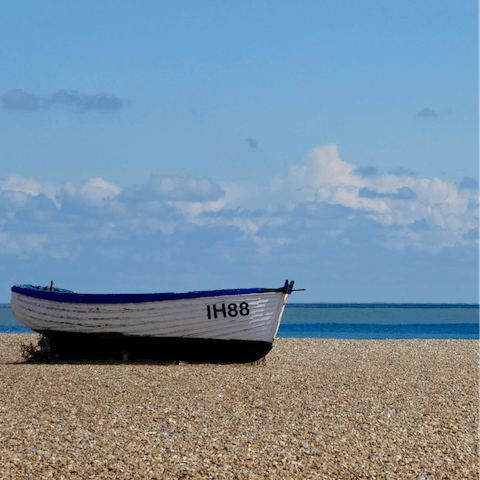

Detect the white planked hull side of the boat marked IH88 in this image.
[11,291,288,343]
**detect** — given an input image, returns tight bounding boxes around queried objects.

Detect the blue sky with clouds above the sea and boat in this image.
[0,0,479,303]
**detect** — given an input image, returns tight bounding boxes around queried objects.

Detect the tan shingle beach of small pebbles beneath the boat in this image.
[0,335,480,480]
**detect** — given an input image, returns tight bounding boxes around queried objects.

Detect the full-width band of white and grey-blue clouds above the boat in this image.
[0,145,478,258]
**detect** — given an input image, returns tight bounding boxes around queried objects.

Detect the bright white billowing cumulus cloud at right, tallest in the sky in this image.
[272,145,478,253]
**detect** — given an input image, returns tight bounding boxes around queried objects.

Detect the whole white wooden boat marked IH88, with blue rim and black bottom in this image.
[11,281,300,363]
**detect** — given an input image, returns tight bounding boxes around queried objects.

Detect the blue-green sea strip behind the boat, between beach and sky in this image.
[0,303,480,340]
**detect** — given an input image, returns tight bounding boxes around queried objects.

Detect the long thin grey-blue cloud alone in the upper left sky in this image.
[2,88,130,113]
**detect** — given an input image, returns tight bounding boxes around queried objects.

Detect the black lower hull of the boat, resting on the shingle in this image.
[39,331,272,363]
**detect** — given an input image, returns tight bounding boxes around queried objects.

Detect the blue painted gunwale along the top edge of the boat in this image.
[12,285,291,304]
